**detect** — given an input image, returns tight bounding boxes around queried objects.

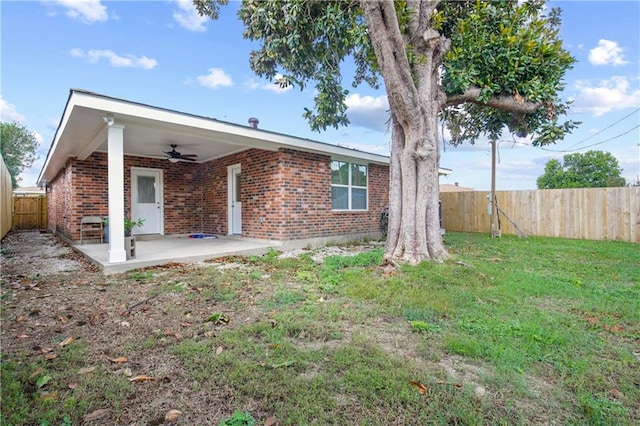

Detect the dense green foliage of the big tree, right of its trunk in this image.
[442,0,579,145]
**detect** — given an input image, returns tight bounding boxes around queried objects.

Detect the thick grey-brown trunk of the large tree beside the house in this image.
[361,0,449,264]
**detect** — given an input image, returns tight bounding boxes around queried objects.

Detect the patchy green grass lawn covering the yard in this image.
[1,233,640,425]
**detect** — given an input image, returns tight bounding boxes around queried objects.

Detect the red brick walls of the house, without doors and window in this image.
[48,149,389,240]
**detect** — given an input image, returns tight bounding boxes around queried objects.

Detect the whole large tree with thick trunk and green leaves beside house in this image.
[194,0,576,263]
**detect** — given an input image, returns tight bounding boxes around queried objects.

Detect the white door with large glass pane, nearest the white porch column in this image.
[131,168,164,235]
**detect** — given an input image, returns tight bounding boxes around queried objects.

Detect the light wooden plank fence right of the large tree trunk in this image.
[440,187,640,243]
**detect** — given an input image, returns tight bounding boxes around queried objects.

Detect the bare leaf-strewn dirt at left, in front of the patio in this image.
[0,232,424,425]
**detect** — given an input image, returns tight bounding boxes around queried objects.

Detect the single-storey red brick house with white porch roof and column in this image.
[38,89,450,263]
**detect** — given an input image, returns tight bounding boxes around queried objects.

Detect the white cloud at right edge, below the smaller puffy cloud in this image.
[572,76,640,117]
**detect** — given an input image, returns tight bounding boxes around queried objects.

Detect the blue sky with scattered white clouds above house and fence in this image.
[0,0,640,190]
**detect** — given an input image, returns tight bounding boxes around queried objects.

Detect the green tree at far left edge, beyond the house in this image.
[0,121,38,189]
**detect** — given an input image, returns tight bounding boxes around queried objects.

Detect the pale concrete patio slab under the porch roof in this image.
[72,235,283,275]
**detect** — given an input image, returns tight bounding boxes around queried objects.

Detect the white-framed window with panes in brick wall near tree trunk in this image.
[331,160,369,210]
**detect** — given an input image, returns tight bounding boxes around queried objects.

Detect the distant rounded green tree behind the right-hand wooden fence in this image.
[536,151,626,189]
